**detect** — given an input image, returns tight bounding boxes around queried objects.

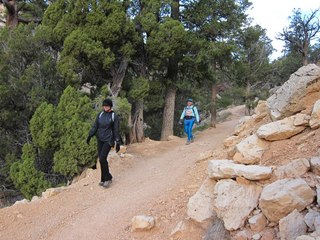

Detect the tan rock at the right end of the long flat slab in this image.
[274,158,310,179]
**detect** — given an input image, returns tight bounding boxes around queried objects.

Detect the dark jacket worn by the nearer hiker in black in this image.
[89,111,120,146]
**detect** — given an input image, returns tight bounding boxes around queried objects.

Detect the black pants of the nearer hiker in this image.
[98,140,112,182]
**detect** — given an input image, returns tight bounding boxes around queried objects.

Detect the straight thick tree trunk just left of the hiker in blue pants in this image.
[161,85,177,141]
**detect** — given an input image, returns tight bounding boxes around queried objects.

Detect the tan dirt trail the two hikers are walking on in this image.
[0,107,243,240]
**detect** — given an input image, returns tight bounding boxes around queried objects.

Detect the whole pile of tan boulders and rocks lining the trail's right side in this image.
[188,64,320,240]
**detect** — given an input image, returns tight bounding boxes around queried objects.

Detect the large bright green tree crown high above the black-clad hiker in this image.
[42,0,137,86]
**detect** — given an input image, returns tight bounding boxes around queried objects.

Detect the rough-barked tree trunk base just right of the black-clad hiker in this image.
[130,100,144,143]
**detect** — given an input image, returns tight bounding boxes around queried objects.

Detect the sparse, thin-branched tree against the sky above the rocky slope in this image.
[278,9,320,65]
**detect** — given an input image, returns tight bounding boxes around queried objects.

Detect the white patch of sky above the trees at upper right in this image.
[248,0,320,59]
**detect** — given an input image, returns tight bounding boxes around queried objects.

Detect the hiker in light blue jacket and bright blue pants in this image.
[179,98,200,145]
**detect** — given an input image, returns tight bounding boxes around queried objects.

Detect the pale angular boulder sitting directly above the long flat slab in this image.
[233,134,269,164]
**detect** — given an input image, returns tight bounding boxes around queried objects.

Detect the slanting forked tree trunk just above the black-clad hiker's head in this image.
[110,59,128,97]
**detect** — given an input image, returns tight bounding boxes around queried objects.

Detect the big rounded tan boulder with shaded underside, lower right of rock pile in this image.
[259,178,315,222]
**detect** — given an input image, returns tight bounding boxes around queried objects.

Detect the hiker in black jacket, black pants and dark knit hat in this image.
[87,99,120,188]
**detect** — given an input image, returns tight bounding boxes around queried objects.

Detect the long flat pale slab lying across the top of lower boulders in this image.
[208,160,272,180]
